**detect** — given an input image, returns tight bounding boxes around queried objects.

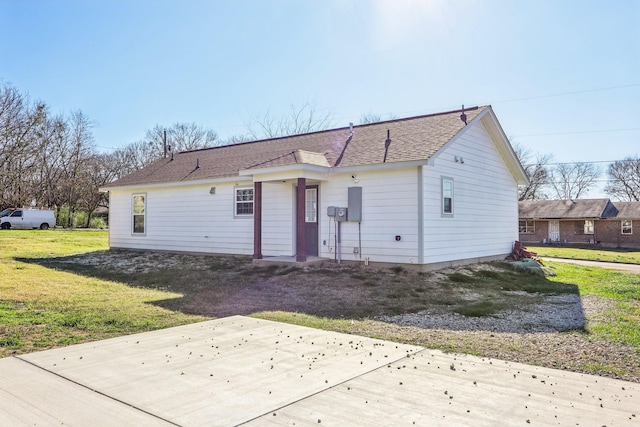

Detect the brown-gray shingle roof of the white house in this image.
[104,106,490,188]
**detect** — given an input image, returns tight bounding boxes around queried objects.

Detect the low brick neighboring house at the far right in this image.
[518,199,640,248]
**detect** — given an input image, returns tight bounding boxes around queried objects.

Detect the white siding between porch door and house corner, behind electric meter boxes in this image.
[319,167,418,263]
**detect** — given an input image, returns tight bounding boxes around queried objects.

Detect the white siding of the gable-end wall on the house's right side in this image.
[424,118,518,264]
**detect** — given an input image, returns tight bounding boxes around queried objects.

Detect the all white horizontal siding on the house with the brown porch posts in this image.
[109,122,518,264]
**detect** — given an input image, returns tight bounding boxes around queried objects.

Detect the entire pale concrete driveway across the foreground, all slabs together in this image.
[0,316,640,427]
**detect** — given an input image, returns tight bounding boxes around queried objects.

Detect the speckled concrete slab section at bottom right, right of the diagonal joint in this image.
[248,350,640,427]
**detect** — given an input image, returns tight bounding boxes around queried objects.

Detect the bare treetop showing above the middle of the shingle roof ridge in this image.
[246,102,332,139]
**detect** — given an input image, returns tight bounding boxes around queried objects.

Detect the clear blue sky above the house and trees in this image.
[0,0,640,196]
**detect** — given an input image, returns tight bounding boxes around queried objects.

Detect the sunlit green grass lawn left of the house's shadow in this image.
[0,230,204,357]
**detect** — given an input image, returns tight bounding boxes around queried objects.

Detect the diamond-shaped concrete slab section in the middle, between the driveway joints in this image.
[12,316,420,426]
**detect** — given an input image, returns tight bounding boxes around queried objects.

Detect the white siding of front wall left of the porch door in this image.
[109,182,295,256]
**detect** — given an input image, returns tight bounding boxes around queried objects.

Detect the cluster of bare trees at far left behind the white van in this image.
[0,82,113,225]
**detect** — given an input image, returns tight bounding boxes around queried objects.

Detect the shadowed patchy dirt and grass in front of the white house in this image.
[43,250,584,331]
